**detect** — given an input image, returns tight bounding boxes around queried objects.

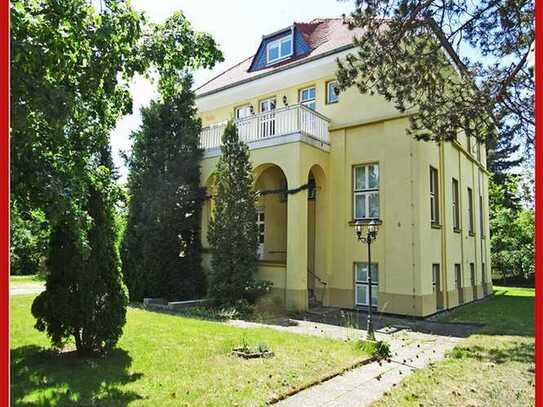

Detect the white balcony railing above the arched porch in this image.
[200,105,330,150]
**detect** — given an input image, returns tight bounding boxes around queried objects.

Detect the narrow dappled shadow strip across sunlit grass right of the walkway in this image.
[449,341,534,364]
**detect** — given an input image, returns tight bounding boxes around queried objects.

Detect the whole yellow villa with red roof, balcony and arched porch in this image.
[196,18,492,316]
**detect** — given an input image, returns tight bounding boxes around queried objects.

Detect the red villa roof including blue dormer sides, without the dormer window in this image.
[196,18,362,97]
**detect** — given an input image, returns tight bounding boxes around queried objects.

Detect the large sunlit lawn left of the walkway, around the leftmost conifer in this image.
[11,296,368,407]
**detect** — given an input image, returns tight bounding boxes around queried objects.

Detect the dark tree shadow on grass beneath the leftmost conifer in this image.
[11,345,143,406]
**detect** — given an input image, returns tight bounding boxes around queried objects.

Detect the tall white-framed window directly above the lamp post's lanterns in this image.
[353,164,379,219]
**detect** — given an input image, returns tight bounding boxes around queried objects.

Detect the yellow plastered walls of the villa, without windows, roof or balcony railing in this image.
[200,71,490,316]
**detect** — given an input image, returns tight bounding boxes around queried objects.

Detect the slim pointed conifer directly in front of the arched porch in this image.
[208,121,265,306]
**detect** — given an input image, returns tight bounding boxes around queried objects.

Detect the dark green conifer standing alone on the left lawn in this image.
[32,161,128,354]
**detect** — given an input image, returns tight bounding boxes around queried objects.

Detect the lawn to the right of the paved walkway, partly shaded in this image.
[375,287,535,407]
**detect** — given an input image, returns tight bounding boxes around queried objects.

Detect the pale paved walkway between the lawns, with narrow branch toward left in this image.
[230,319,477,407]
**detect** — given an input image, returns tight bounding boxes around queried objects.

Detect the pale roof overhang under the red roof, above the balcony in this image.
[196,44,353,112]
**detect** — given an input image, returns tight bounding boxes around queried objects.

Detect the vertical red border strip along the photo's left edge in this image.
[0,0,10,406]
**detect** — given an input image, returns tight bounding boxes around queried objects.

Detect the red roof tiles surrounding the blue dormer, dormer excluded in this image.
[196,18,361,96]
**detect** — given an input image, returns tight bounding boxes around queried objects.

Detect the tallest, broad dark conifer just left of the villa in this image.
[122,77,205,300]
